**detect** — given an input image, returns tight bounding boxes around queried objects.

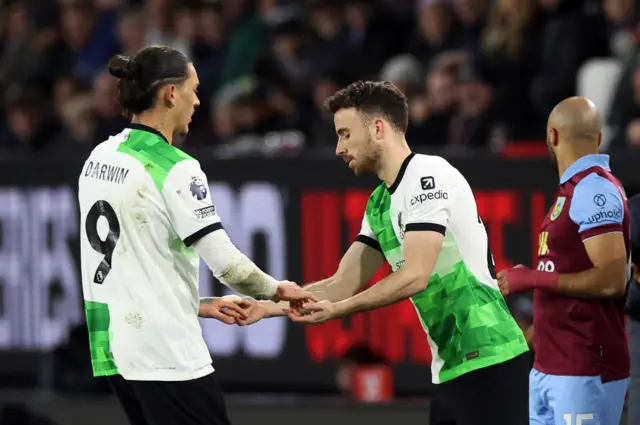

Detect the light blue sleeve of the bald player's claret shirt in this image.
[569,174,624,240]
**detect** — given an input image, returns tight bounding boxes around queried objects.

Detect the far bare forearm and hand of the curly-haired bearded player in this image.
[264,241,384,317]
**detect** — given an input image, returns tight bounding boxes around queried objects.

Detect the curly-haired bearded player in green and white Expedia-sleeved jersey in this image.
[258,81,529,425]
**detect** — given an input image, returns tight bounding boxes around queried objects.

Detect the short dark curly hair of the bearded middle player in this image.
[325,81,409,133]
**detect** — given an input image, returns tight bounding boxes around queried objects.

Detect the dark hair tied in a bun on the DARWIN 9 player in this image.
[109,46,190,116]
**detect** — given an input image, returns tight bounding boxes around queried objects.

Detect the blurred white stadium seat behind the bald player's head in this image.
[577,58,623,150]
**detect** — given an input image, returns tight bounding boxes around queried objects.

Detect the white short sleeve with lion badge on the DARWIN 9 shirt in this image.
[162,160,222,246]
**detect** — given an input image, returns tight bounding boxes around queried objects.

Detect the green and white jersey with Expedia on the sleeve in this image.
[358,154,528,384]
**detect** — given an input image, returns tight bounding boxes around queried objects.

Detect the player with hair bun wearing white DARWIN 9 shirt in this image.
[79,47,313,425]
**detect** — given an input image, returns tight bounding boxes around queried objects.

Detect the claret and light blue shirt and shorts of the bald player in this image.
[530,154,630,425]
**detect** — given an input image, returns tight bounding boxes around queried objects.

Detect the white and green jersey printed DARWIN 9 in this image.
[78,124,222,381]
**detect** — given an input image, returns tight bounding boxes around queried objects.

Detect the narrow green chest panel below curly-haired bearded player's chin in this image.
[366,184,400,255]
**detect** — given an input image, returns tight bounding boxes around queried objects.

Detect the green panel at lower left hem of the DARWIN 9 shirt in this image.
[84,300,118,376]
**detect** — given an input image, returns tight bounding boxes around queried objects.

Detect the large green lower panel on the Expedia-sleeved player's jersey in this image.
[412,261,528,382]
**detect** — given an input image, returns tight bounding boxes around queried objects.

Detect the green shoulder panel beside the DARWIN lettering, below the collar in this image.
[118,130,193,192]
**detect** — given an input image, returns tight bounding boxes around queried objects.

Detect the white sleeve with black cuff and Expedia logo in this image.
[405,165,455,235]
